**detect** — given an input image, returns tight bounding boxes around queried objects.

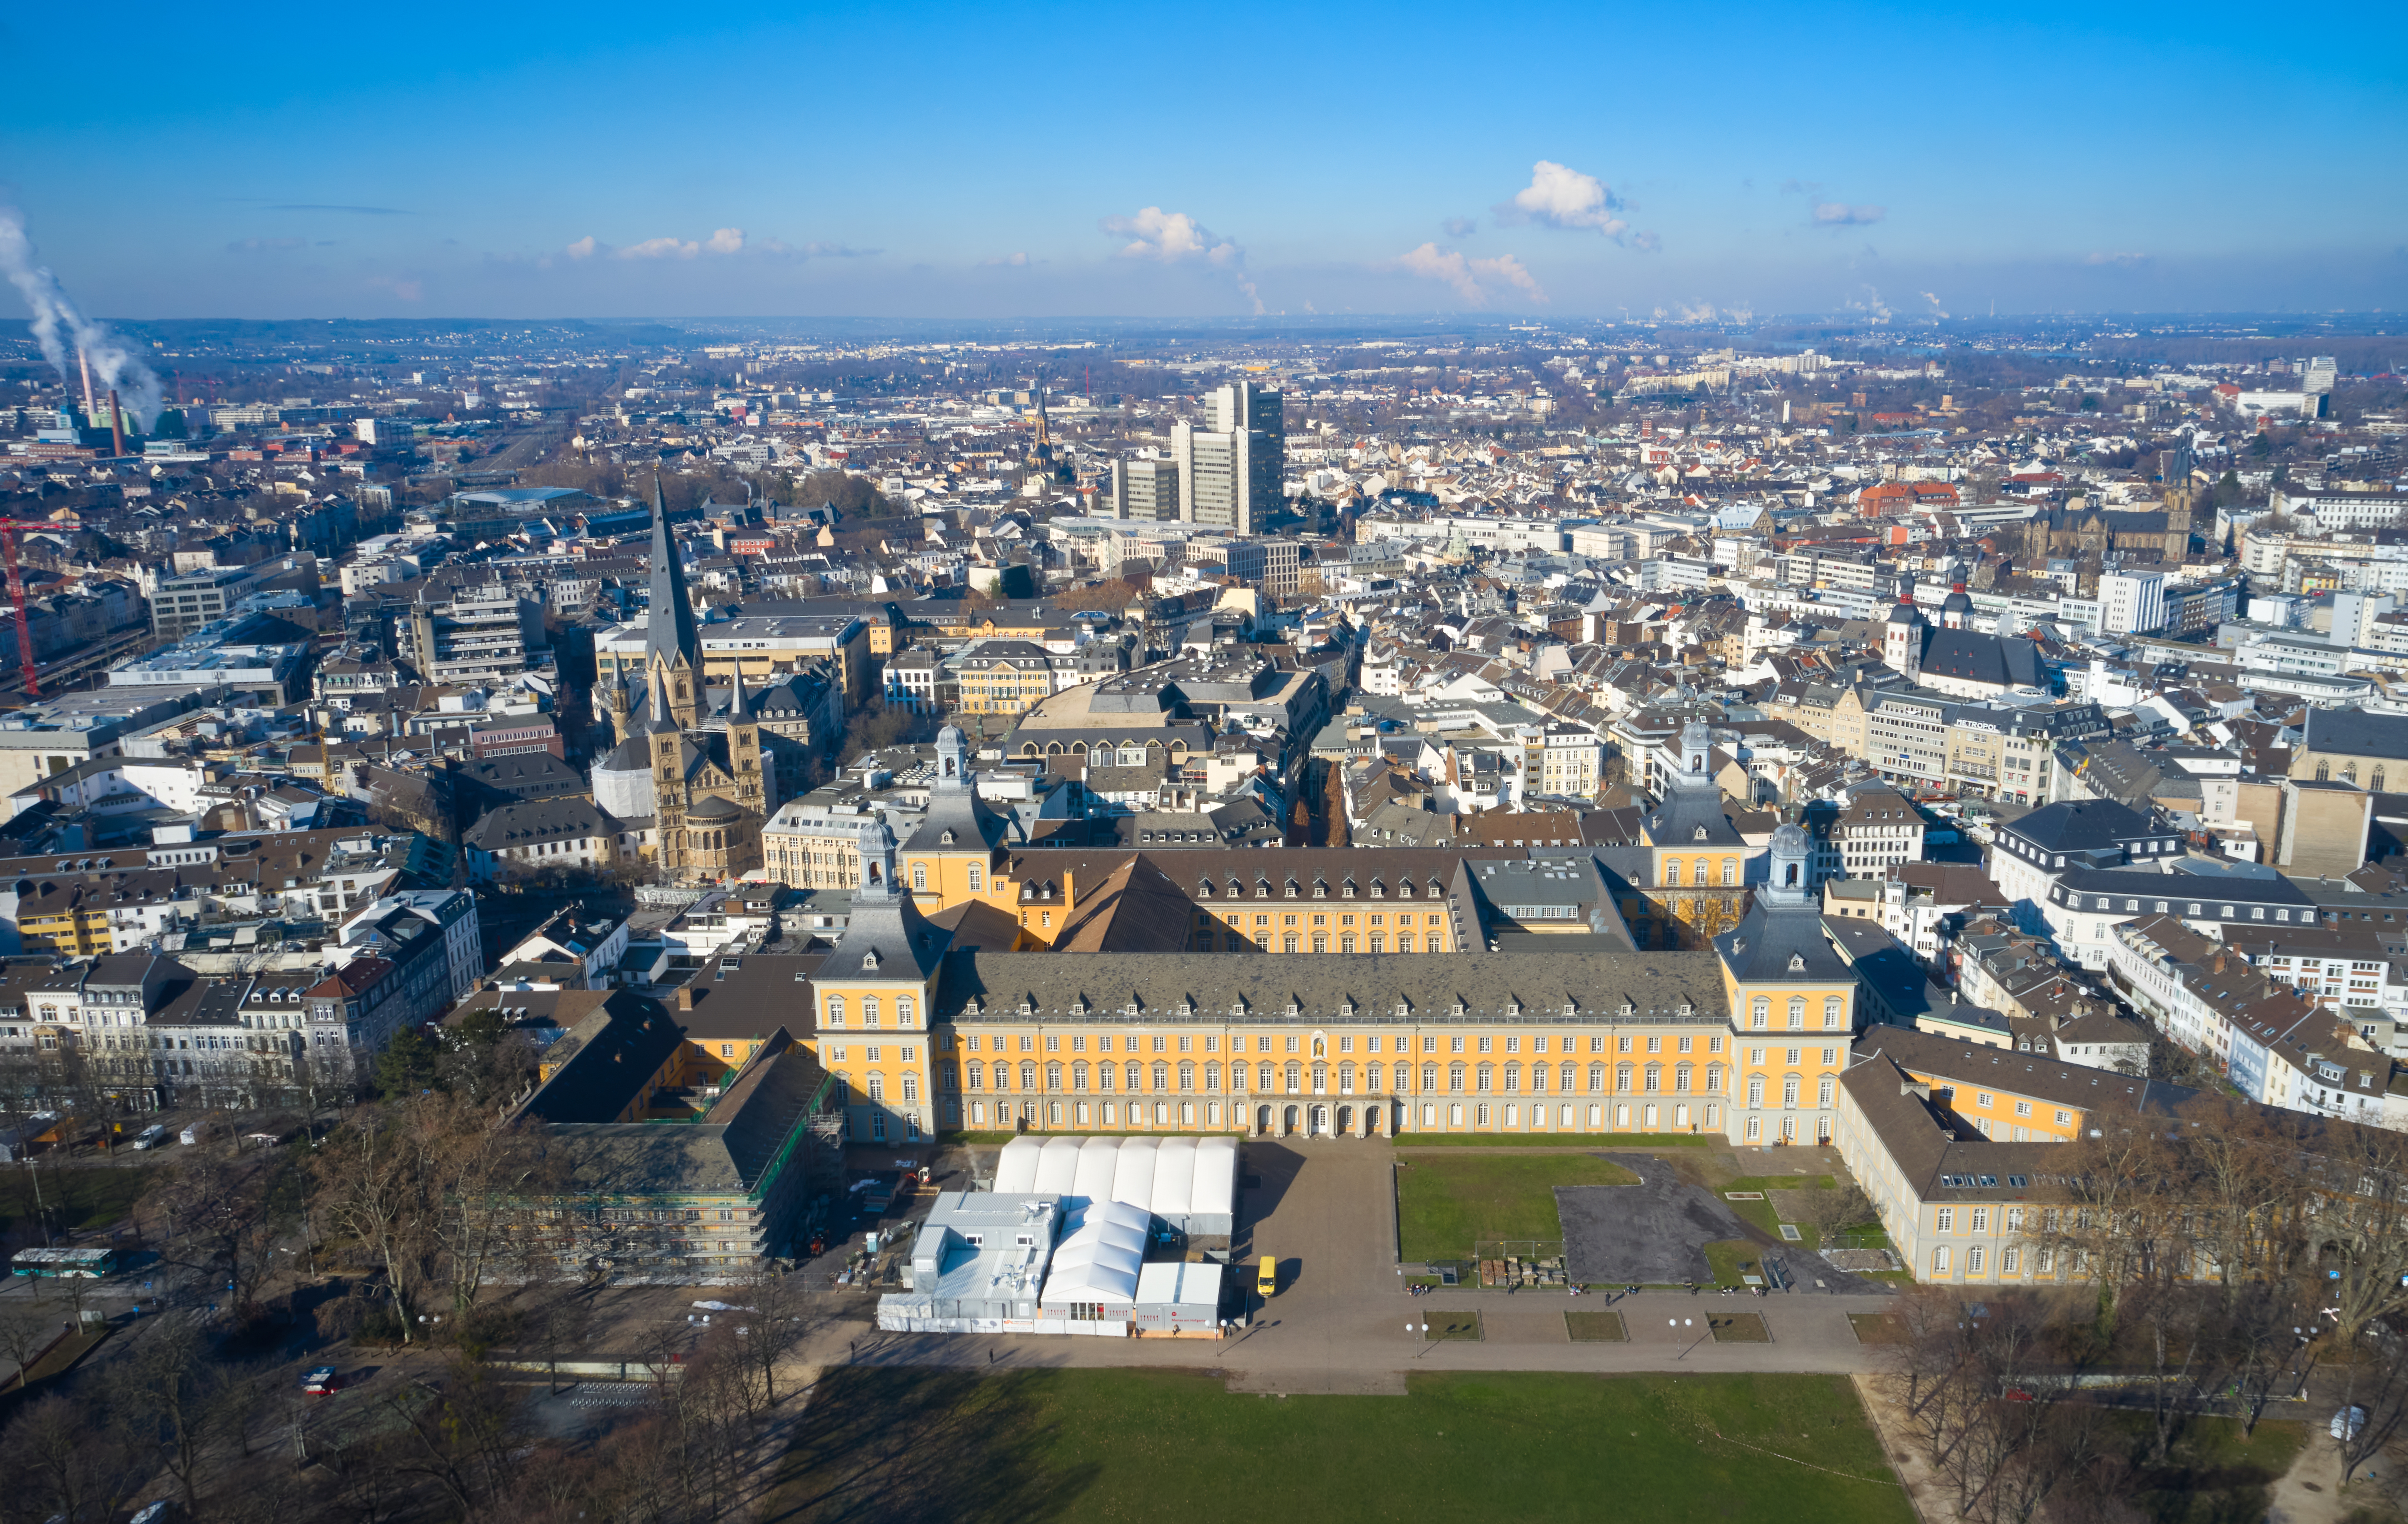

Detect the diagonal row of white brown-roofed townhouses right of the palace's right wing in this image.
[2107,915,2408,1127]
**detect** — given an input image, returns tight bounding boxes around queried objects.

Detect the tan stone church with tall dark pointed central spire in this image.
[595,482,778,881]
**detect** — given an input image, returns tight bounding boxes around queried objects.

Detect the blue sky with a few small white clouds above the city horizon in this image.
[0,2,2408,318]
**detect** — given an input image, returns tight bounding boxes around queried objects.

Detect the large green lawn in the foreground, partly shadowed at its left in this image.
[780,1367,1914,1524]
